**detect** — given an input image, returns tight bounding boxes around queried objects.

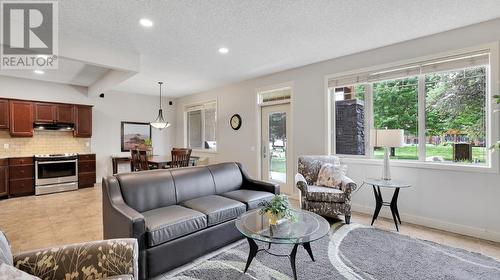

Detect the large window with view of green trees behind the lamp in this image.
[328,51,490,165]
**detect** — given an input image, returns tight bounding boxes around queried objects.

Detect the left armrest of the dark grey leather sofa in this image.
[102,176,146,240]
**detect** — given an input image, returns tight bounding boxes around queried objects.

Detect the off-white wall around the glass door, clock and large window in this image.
[176,19,500,241]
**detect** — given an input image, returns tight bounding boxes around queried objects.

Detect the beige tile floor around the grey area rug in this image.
[0,185,500,260]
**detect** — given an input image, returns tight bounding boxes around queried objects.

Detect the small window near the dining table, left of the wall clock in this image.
[186,102,217,151]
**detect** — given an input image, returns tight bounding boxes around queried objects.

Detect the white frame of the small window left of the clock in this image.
[184,99,219,153]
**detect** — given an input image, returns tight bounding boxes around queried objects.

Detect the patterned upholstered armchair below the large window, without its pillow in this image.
[295,156,356,224]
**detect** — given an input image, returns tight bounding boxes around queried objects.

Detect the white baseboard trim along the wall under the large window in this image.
[351,204,500,242]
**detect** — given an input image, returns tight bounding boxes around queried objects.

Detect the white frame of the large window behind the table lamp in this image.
[324,42,500,173]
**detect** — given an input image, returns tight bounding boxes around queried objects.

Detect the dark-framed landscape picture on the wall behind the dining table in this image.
[121,122,151,152]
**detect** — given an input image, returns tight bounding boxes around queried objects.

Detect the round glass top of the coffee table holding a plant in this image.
[236,209,330,244]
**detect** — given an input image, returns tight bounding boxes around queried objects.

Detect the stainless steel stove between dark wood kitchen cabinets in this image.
[35,154,78,195]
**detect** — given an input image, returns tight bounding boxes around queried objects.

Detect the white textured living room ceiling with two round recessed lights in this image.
[24,0,500,96]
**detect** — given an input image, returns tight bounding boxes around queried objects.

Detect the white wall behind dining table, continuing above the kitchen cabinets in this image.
[0,76,175,179]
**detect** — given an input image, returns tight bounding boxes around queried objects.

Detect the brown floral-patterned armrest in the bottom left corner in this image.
[14,238,139,279]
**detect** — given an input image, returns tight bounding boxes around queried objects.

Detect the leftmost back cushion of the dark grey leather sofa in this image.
[116,170,177,212]
